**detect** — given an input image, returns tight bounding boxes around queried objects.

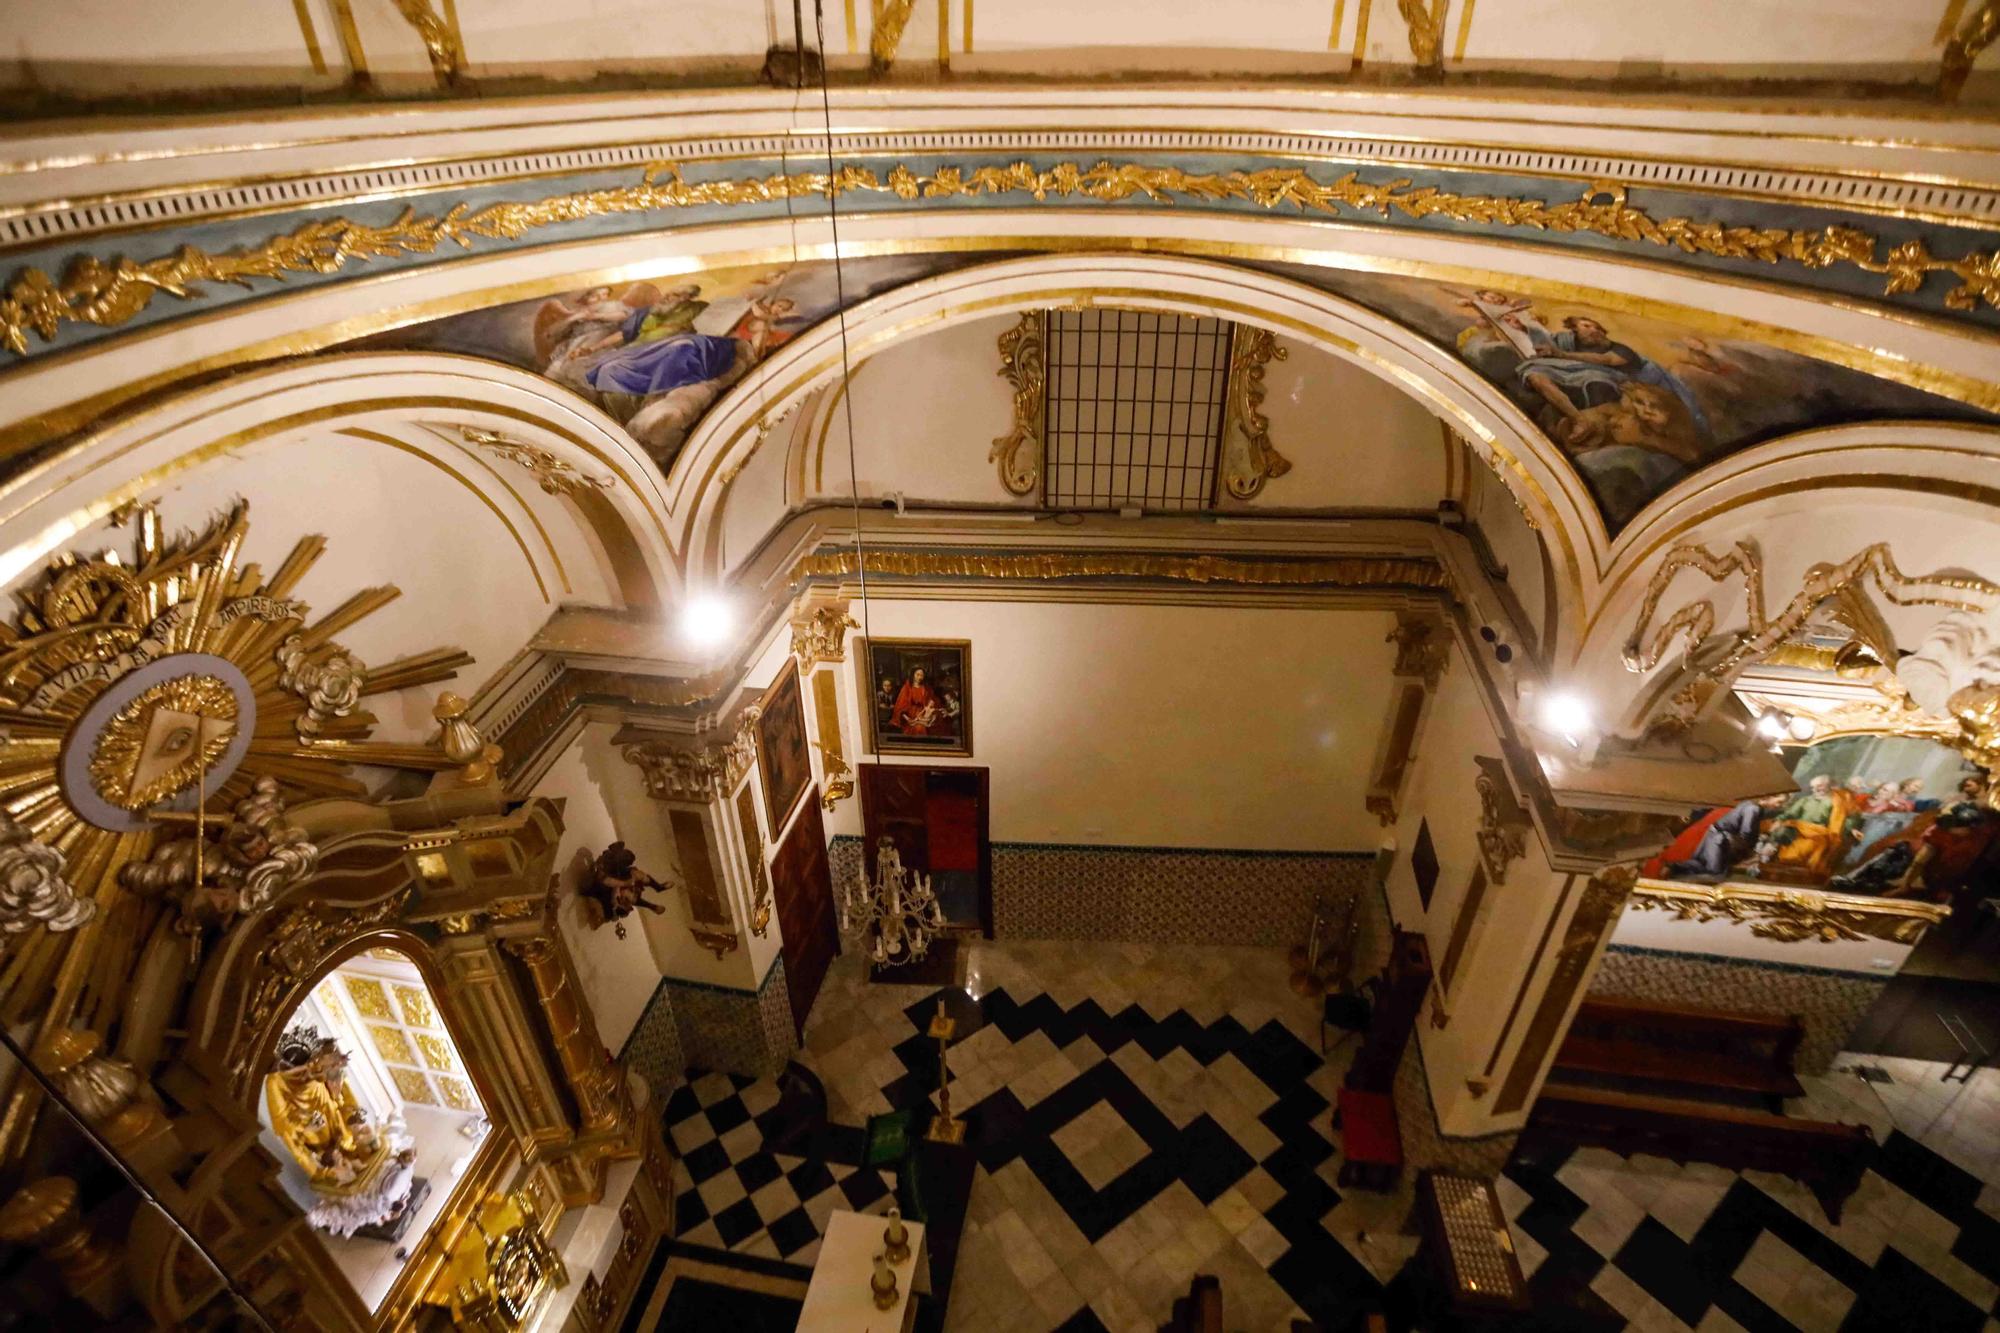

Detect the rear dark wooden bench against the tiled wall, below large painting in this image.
[1554,999,1806,1111]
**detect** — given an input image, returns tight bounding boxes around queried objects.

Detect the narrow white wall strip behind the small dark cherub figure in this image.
[534,723,662,1055]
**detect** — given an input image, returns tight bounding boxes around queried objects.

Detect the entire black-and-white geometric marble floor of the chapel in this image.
[648,943,2000,1333]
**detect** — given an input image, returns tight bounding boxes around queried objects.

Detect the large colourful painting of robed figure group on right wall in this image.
[1642,737,2000,907]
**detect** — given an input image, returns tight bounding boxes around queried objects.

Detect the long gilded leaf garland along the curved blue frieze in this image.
[0,160,2000,356]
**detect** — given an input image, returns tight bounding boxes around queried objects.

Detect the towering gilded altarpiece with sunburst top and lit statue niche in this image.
[0,504,666,1333]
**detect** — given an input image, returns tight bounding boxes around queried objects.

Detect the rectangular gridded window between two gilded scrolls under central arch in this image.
[1042,308,1230,510]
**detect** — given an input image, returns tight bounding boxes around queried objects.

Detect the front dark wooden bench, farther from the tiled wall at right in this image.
[1524,1083,1876,1227]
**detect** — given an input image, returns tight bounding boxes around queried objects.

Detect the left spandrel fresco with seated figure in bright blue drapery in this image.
[354,254,1016,470]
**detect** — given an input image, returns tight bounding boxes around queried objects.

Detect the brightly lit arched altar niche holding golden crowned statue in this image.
[258,949,492,1311]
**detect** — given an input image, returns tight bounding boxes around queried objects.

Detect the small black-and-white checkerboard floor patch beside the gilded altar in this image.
[666,1073,896,1269]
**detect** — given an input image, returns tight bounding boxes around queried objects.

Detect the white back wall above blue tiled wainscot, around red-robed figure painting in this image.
[842,596,1394,851]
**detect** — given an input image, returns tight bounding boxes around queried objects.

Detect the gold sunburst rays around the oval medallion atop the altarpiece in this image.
[0,502,472,1167]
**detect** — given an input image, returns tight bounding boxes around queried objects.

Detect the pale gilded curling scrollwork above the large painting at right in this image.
[1624,540,2000,735]
